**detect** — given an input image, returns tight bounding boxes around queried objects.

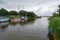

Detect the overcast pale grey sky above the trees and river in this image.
[0,0,60,16]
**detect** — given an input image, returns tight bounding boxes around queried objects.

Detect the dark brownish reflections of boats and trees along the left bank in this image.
[0,19,35,30]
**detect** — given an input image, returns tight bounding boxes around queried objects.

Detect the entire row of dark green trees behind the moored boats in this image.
[0,8,36,17]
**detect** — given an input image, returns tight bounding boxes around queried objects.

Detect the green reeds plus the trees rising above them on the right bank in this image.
[48,5,60,40]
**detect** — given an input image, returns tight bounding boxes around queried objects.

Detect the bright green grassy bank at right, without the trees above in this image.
[48,17,60,40]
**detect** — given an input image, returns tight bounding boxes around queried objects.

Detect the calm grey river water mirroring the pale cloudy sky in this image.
[0,17,49,40]
